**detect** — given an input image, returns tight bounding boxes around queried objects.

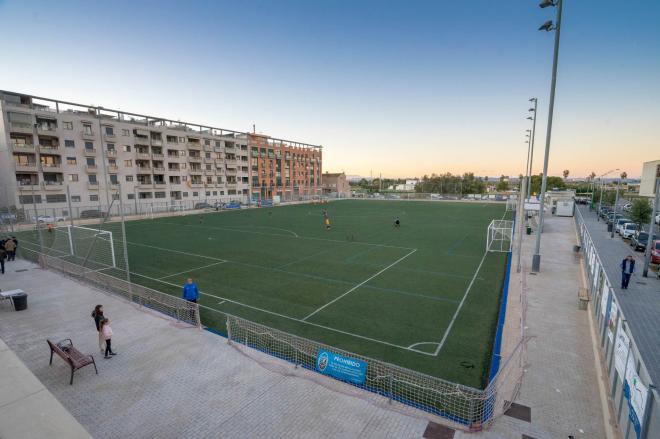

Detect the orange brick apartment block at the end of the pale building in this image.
[248,134,322,201]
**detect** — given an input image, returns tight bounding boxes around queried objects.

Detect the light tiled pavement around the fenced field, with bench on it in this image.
[0,218,606,439]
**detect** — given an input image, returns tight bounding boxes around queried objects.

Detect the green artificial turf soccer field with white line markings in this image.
[24,200,506,388]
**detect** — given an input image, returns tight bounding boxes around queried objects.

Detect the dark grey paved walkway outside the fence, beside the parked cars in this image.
[580,207,660,383]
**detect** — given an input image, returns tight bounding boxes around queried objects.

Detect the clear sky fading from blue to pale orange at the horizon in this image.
[0,0,660,177]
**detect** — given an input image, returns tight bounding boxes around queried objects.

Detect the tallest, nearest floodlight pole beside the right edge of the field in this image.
[532,0,562,273]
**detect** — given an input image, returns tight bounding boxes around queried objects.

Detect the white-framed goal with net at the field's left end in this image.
[45,226,117,270]
